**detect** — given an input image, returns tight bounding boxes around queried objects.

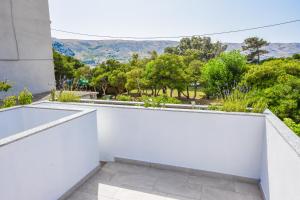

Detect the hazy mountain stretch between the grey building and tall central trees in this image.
[52,38,177,65]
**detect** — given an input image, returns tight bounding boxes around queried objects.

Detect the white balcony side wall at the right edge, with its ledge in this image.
[261,113,300,200]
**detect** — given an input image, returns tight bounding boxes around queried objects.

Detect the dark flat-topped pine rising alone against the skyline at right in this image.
[242,37,269,63]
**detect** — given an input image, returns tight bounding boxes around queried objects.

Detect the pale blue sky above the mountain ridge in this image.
[49,0,300,42]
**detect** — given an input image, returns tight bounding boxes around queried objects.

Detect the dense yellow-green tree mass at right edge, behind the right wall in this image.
[240,59,300,123]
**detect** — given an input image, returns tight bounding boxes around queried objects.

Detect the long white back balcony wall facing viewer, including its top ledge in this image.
[38,103,265,179]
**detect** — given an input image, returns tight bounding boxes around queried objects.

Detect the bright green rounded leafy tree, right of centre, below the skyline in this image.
[202,51,246,97]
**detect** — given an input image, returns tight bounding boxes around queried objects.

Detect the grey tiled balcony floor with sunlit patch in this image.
[68,162,262,200]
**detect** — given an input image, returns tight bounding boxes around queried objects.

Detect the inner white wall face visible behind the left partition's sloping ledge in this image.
[0,107,78,139]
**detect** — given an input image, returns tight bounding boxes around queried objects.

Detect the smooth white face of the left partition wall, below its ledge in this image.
[0,109,99,200]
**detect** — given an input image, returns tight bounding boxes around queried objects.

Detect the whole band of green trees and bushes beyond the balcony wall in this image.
[54,37,300,136]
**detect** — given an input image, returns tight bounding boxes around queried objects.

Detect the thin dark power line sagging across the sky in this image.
[51,19,300,40]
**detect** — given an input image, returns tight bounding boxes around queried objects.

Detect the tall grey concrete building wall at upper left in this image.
[0,0,55,98]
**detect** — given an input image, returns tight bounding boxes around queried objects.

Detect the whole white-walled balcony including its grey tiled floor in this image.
[0,102,300,200]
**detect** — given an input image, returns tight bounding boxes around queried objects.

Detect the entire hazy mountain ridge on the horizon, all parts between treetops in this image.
[52,38,300,65]
